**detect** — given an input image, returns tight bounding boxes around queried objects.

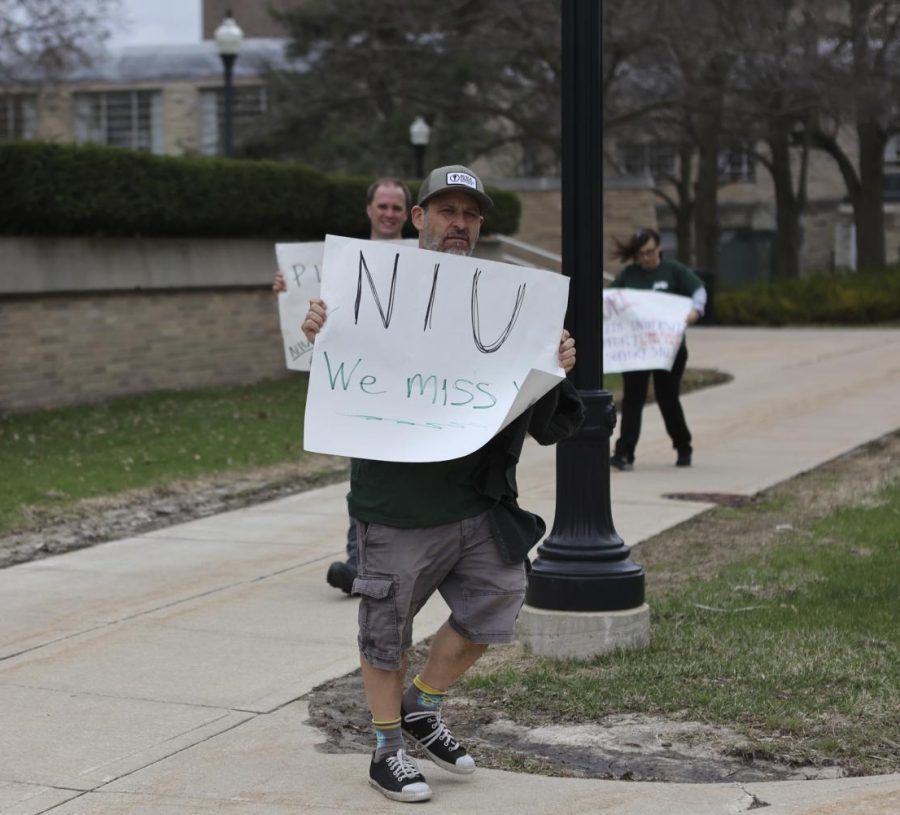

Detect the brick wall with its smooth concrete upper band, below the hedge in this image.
[0,238,286,412]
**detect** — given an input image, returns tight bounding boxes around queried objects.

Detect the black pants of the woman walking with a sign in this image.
[615,342,692,461]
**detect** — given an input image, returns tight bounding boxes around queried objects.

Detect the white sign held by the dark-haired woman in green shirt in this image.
[603,288,692,373]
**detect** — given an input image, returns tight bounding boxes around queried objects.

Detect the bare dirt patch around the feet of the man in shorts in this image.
[306,642,846,783]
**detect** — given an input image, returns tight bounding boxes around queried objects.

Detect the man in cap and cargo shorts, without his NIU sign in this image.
[303,165,584,801]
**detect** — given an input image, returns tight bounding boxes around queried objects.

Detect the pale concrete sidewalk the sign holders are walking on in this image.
[0,328,900,815]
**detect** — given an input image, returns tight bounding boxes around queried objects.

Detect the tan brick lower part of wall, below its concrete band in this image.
[0,288,286,412]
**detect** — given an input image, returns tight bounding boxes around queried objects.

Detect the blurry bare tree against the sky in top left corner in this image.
[0,0,119,80]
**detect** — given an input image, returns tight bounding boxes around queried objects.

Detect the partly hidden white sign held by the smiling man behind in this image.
[275,240,417,371]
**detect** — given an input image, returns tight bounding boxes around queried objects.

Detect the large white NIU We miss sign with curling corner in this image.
[303,235,569,461]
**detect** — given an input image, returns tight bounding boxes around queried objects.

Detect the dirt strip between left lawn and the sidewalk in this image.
[0,456,348,568]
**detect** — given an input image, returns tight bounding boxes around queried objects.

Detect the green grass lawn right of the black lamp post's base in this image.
[464,458,900,774]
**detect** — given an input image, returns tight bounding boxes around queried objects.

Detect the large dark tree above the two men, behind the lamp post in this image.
[252,0,659,175]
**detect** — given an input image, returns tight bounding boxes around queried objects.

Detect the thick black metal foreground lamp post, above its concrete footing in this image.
[525,0,644,611]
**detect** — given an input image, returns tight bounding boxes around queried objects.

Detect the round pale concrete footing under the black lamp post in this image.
[516,603,650,659]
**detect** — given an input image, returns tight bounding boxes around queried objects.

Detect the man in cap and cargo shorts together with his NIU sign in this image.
[303,165,584,801]
